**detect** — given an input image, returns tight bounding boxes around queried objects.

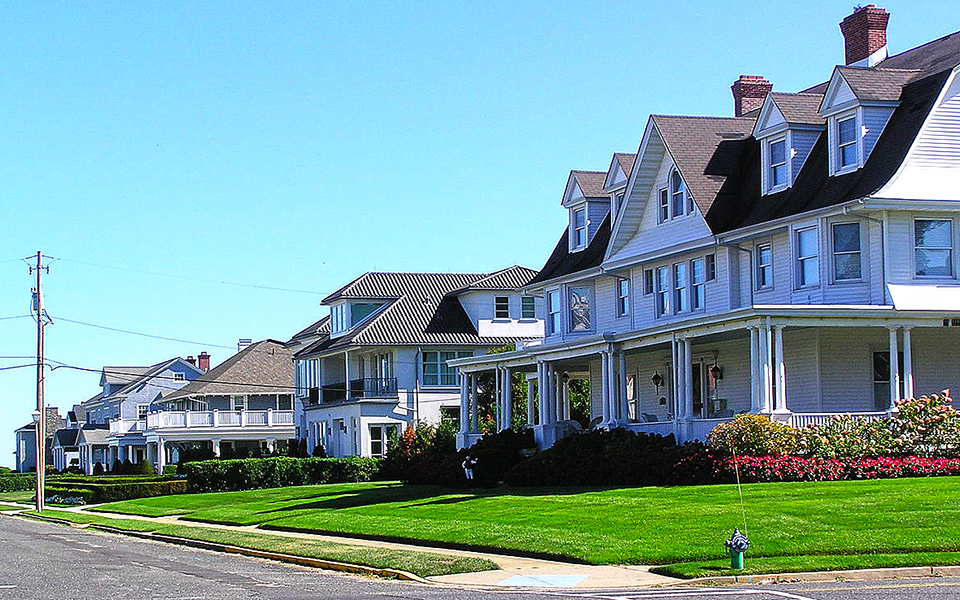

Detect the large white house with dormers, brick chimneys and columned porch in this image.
[451,5,960,446]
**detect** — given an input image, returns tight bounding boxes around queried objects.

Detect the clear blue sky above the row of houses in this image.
[0,1,948,464]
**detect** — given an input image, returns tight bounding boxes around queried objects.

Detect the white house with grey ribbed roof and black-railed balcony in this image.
[288,266,543,456]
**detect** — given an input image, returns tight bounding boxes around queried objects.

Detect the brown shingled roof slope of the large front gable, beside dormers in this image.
[651,115,756,215]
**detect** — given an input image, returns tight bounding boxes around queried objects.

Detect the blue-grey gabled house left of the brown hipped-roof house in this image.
[78,353,210,473]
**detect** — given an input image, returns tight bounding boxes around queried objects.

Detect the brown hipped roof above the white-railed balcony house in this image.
[161,340,293,402]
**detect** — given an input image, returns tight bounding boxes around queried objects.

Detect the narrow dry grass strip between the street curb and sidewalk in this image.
[24,510,498,577]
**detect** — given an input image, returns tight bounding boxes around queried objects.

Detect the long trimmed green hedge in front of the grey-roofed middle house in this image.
[179,456,380,494]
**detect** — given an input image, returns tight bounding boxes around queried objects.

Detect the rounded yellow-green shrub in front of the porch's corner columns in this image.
[707,414,799,456]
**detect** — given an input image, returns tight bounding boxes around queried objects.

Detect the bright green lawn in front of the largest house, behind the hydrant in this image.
[94,477,960,568]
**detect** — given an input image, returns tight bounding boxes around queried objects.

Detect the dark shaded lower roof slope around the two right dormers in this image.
[706,71,949,233]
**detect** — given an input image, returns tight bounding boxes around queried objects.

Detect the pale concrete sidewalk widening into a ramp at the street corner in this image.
[16,505,681,589]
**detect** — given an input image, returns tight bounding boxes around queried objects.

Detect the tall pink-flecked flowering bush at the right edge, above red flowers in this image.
[890,390,960,456]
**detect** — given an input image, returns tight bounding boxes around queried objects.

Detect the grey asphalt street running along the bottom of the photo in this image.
[0,517,960,600]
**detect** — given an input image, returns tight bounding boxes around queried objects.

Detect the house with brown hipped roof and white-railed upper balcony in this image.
[146,340,296,469]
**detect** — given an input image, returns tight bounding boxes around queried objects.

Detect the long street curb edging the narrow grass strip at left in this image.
[17,515,438,586]
